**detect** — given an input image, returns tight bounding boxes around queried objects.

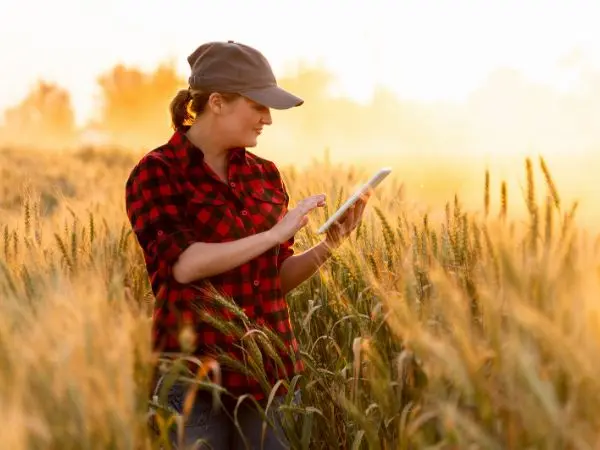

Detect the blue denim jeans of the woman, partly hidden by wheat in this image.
[151,383,300,450]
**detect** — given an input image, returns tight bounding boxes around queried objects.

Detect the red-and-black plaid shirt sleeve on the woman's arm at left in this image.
[125,158,194,278]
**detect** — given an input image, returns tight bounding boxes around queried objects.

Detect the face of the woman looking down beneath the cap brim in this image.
[216,96,273,147]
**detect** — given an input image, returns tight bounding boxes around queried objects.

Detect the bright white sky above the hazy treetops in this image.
[0,0,600,123]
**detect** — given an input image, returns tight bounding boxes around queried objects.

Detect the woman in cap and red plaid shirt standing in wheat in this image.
[126,41,367,449]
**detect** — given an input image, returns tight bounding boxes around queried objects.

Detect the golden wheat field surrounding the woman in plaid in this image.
[0,145,600,450]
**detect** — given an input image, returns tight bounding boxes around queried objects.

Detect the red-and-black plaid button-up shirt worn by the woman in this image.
[126,132,304,401]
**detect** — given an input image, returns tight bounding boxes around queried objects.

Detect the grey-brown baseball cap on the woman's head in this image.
[187,41,304,109]
